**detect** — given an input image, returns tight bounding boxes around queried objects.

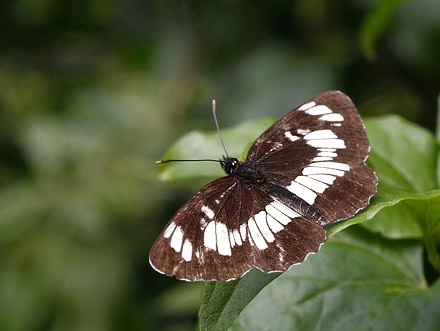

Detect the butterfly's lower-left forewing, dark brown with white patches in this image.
[150,177,250,281]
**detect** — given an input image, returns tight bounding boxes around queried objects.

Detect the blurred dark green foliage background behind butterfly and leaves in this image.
[0,0,440,331]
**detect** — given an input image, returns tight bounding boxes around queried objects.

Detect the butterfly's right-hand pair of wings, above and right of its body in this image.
[246,91,377,224]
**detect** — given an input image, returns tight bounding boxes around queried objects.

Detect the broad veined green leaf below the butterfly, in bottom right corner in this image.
[231,227,440,331]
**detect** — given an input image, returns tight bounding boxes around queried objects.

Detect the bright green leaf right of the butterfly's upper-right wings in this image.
[338,116,440,239]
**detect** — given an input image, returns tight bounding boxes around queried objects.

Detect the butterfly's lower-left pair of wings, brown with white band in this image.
[150,177,325,281]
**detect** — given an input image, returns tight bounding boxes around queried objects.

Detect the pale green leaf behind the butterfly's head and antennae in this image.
[160,118,274,181]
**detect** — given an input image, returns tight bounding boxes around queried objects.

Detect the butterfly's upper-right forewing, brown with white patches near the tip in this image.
[246,91,370,167]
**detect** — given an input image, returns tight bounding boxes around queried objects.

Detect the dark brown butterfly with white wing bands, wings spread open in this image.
[149,91,378,281]
